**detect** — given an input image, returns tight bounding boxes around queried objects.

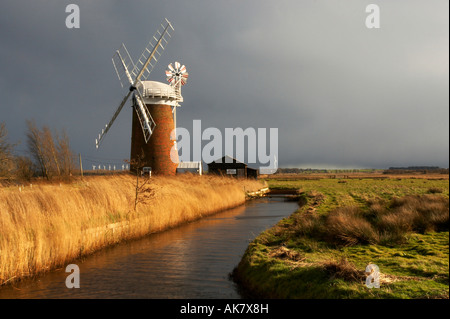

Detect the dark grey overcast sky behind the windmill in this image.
[0,0,449,168]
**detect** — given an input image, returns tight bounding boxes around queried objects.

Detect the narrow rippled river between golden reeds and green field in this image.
[0,198,298,299]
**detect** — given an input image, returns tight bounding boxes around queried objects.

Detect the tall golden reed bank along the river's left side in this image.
[0,175,262,285]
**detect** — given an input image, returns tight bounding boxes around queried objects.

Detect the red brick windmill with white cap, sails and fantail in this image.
[95,19,188,175]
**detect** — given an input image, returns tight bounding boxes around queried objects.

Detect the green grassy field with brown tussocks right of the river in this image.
[234,176,449,298]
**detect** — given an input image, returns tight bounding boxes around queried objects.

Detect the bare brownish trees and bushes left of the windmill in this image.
[0,121,74,181]
